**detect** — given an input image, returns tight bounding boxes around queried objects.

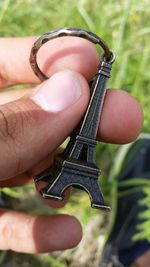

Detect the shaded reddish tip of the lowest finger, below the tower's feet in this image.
[34,215,82,253]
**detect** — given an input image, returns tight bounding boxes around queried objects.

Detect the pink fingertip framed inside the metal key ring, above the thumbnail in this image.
[38,36,99,80]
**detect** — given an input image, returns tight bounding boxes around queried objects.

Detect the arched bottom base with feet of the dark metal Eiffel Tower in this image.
[41,172,110,210]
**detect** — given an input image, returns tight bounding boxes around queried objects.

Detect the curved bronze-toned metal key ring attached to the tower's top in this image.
[30,28,115,81]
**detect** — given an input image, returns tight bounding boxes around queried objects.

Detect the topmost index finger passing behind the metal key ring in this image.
[0,37,98,88]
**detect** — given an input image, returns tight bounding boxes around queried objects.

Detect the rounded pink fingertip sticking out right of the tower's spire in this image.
[98,89,143,144]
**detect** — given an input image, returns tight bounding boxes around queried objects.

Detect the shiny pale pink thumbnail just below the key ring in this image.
[31,71,82,112]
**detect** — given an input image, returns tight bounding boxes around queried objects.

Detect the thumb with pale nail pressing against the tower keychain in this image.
[0,70,89,180]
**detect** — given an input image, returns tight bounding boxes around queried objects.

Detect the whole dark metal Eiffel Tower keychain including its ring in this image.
[30,28,115,209]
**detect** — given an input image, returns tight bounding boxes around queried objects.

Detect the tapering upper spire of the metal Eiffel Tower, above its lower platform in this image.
[67,61,111,163]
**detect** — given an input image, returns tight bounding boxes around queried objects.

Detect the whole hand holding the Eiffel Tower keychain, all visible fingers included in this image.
[0,37,143,253]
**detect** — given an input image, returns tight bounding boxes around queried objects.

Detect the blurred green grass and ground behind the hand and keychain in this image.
[0,0,150,267]
